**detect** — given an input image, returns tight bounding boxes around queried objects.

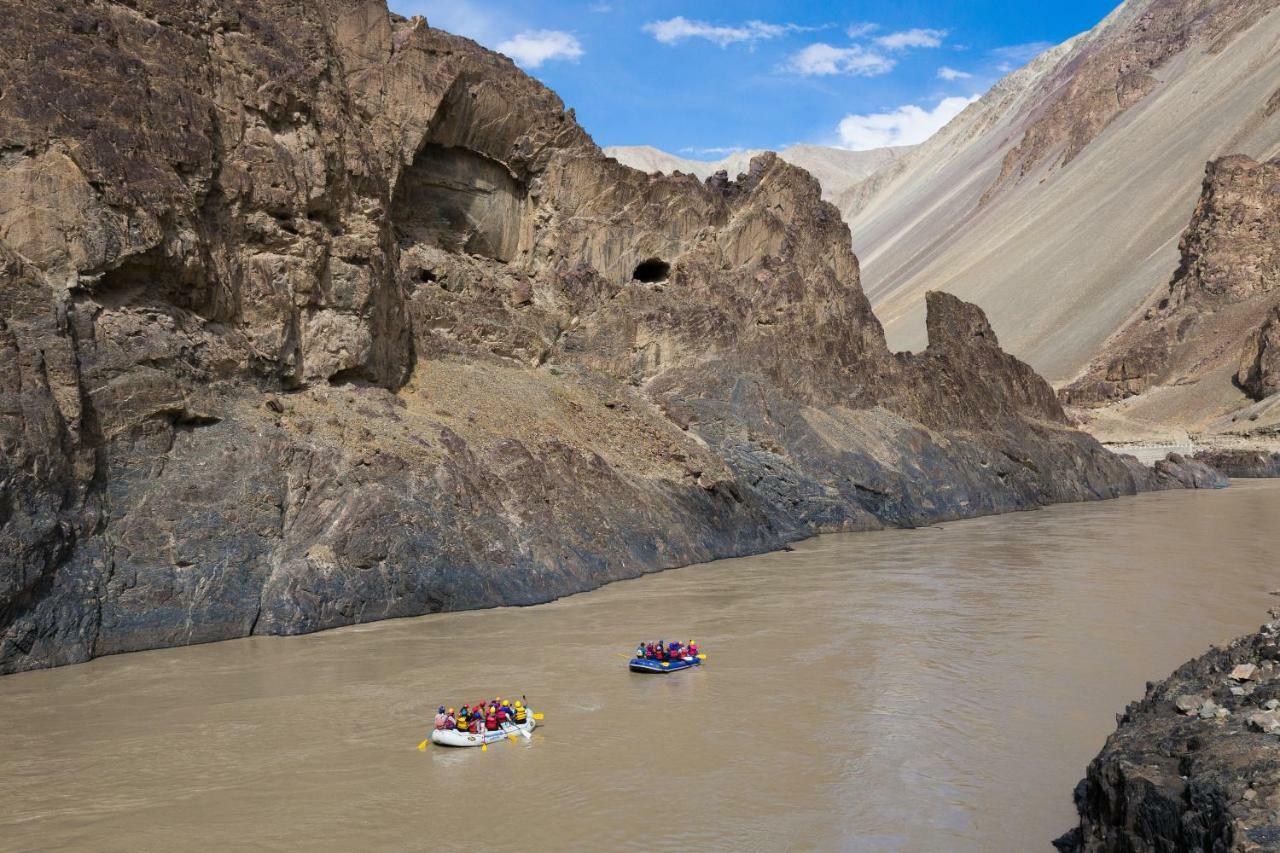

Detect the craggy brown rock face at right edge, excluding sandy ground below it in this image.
[1062,156,1280,432]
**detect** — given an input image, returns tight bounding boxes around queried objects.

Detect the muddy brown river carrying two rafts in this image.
[0,482,1280,853]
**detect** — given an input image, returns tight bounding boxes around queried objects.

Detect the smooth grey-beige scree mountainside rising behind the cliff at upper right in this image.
[841,0,1280,380]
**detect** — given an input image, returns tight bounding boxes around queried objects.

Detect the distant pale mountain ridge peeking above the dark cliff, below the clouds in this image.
[604,145,911,208]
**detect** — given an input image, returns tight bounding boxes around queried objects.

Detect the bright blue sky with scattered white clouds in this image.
[390,0,1117,159]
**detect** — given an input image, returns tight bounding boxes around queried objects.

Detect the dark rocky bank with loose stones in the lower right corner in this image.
[1056,620,1280,853]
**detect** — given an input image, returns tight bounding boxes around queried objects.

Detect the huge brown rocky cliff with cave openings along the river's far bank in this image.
[0,0,1207,672]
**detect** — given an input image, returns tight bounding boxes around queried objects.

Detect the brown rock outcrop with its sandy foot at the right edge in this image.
[1061,155,1280,450]
